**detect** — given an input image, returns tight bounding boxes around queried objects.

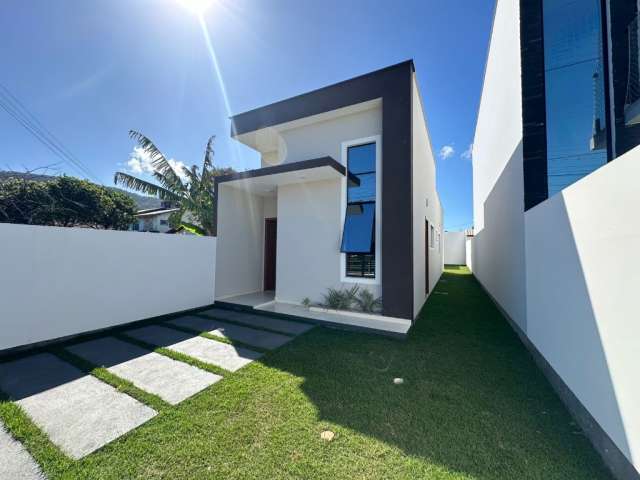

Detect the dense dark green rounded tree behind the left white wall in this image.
[0,176,136,230]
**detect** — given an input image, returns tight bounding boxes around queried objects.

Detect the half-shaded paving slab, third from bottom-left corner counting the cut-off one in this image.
[67,337,222,405]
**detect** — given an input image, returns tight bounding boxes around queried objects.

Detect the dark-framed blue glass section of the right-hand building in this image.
[520,0,640,209]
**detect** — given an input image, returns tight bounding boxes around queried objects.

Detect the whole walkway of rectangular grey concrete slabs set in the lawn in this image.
[0,308,313,470]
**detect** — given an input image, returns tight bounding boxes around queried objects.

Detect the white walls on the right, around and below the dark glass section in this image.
[468,0,640,472]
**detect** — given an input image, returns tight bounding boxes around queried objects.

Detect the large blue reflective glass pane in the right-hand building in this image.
[543,0,608,196]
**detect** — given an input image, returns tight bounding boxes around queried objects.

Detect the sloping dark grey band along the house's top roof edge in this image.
[231,60,415,136]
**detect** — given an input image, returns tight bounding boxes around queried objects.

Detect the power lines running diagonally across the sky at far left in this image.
[0,84,101,183]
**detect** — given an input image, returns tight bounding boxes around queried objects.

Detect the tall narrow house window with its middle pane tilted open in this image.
[340,142,376,278]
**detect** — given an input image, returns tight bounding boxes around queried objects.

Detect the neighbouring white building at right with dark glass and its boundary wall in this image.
[468,0,640,479]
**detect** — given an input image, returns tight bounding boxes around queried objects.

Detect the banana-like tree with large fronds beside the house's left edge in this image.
[113,130,234,236]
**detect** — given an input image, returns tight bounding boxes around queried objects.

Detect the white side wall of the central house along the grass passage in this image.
[411,74,444,318]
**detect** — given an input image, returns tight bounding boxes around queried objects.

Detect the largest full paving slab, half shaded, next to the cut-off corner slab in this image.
[0,353,156,459]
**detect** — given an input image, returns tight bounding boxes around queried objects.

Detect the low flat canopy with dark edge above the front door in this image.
[215,157,358,196]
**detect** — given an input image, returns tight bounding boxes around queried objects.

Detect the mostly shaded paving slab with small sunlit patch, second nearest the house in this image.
[167,316,293,350]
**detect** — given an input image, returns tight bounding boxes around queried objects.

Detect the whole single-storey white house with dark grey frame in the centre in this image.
[216,61,443,325]
